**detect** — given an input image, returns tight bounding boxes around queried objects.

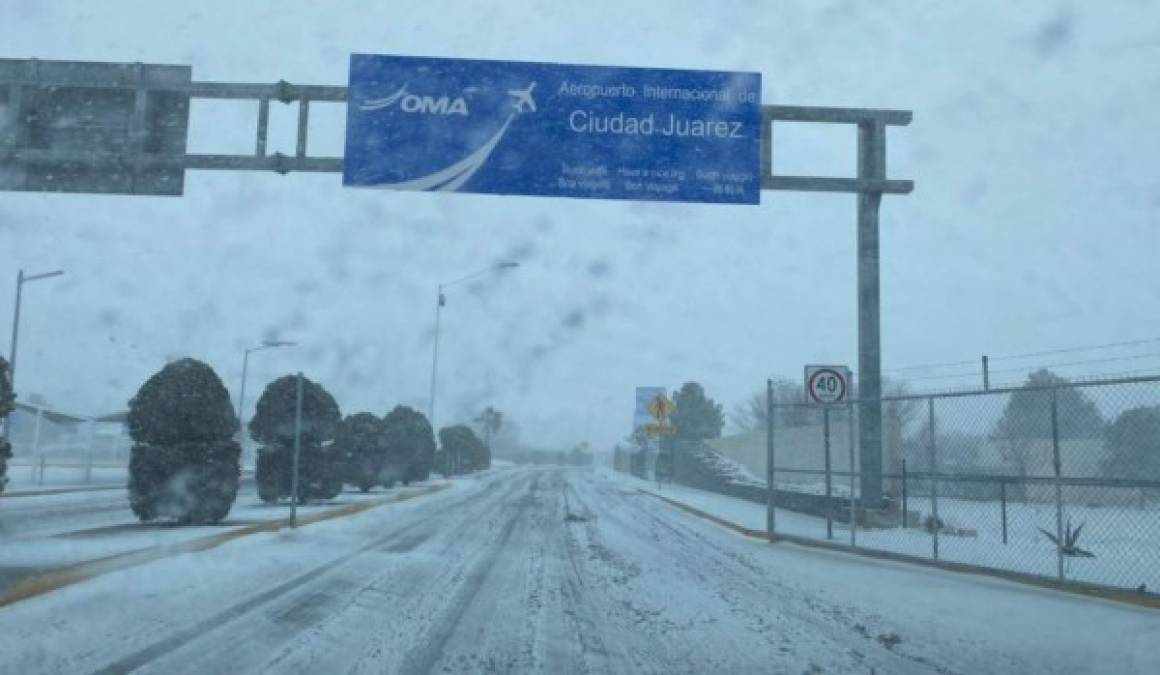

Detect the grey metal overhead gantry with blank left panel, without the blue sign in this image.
[0,59,914,503]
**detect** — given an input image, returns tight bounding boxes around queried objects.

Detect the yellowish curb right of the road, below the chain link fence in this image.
[637,487,1160,609]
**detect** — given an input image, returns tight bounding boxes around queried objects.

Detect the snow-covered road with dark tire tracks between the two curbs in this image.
[0,467,1160,674]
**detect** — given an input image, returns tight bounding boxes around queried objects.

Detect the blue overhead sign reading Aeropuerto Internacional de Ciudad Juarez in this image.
[342,55,761,204]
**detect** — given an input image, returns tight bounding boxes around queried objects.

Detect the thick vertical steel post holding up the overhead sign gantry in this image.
[857,121,886,509]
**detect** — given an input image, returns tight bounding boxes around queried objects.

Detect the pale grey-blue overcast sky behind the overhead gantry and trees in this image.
[0,0,1160,448]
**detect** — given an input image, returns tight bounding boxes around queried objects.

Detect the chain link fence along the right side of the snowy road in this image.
[644,377,1160,594]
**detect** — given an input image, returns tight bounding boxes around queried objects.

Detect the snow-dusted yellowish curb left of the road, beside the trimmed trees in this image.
[0,482,451,608]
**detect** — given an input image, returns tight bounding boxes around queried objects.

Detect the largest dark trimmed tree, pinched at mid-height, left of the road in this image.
[129,358,241,523]
